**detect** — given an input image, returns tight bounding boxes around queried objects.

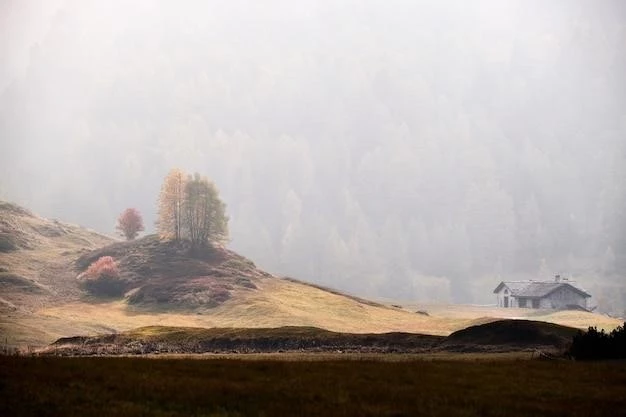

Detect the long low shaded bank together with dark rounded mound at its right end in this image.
[38,320,577,355]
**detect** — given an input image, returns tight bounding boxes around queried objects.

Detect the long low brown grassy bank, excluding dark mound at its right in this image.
[39,326,443,355]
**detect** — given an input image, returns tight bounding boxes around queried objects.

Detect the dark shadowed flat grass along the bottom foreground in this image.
[0,357,626,416]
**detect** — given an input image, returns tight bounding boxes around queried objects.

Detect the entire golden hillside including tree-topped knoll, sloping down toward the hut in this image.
[0,202,621,347]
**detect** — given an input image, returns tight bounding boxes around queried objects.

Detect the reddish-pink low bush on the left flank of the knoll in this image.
[78,256,126,296]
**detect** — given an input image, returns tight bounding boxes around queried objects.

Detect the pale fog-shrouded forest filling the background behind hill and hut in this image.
[0,0,626,313]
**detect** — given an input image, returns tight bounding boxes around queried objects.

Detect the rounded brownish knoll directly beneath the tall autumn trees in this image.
[75,235,272,311]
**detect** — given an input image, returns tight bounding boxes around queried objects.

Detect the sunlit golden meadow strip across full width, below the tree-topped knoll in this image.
[0,279,623,347]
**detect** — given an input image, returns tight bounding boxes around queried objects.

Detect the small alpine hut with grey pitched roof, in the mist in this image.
[493,275,591,310]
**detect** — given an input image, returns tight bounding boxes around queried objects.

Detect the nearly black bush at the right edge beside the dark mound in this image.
[569,323,626,360]
